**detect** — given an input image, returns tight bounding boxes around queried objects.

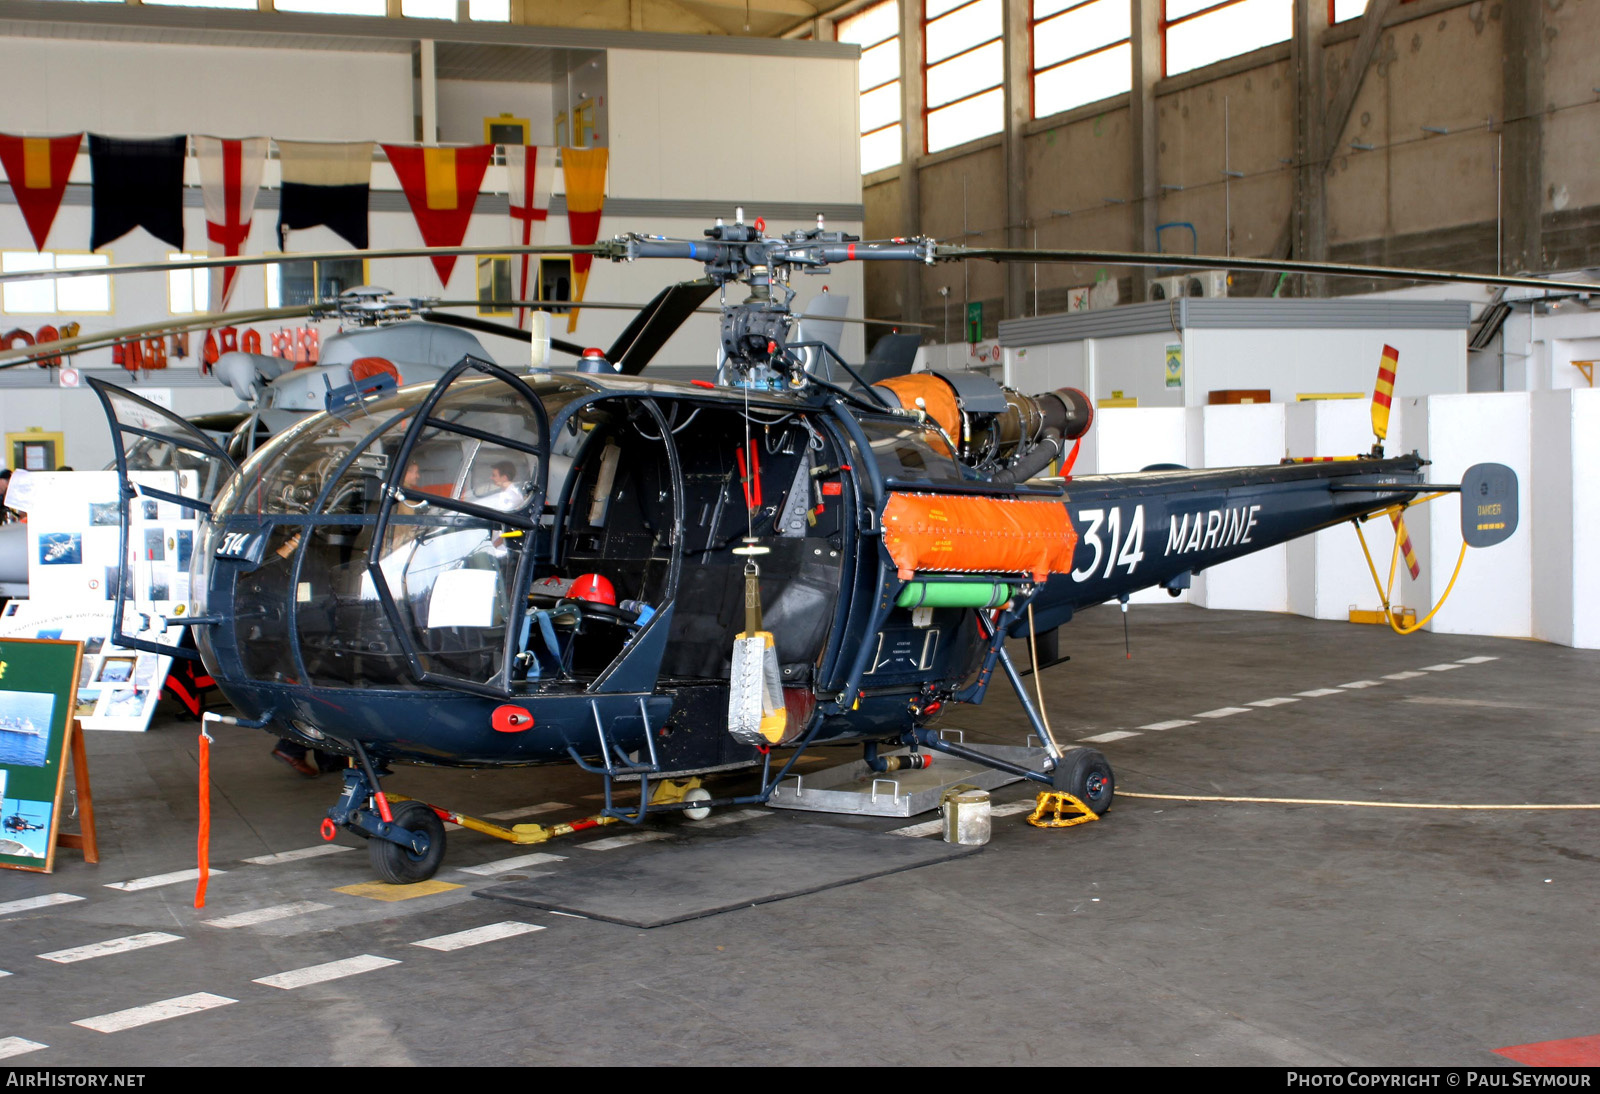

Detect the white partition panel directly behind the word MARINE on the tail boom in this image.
[1187,403,1290,611]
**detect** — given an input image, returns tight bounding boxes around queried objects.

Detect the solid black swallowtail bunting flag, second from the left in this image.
[90,133,189,251]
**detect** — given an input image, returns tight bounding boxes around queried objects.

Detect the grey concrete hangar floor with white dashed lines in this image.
[0,605,1600,1065]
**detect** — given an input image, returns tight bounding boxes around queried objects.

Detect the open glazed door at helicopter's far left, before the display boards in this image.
[88,377,238,659]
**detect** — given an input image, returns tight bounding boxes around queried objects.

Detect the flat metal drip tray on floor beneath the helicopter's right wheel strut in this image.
[766,731,1046,817]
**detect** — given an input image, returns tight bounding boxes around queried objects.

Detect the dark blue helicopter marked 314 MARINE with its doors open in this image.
[0,218,1548,883]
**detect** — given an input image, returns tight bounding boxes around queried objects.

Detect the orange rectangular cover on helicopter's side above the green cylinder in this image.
[883,493,1078,581]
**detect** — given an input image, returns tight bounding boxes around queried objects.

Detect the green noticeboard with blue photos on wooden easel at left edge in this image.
[0,638,83,873]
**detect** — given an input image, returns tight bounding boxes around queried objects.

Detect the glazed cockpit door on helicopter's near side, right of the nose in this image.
[366,357,549,697]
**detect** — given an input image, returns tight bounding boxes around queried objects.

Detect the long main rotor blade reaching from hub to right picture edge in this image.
[933,245,1600,293]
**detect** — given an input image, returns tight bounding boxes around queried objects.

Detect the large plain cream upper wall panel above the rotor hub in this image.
[606,50,861,203]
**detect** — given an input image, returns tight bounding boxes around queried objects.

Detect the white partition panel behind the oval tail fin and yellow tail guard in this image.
[1401,392,1536,637]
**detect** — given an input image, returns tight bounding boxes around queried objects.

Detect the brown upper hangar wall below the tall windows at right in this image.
[864,0,1600,336]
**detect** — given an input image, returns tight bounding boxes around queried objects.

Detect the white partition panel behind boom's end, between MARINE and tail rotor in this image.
[1285,398,1411,619]
